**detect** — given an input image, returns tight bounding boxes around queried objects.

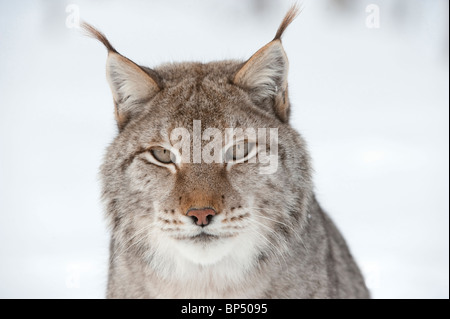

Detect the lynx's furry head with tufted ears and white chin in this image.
[84,7,312,268]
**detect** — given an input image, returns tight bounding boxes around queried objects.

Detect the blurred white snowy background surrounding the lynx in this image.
[0,0,449,298]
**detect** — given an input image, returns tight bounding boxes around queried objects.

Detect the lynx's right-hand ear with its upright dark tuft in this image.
[233,5,299,122]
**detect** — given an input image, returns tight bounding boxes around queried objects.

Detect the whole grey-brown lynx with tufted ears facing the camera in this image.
[83,6,369,298]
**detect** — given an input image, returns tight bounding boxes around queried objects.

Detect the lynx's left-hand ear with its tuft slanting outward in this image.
[82,23,160,130]
